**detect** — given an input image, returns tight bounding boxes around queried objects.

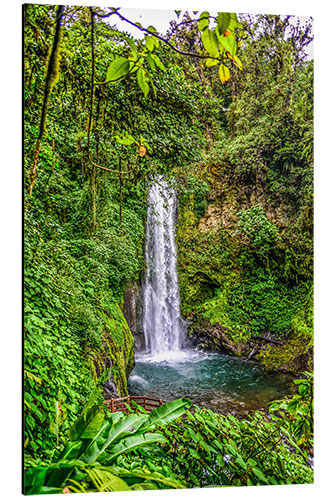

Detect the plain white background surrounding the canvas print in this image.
[0,0,333,500]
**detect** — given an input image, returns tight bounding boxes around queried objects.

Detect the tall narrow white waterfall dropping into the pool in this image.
[143,176,185,359]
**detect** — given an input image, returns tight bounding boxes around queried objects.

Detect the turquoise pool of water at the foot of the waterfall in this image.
[128,351,295,413]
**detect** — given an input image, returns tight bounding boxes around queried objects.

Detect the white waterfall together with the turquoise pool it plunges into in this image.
[128,176,292,413]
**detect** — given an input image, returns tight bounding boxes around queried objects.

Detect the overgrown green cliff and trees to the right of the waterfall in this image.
[178,13,313,369]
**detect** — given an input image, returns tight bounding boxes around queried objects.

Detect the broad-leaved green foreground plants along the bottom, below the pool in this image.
[25,384,313,494]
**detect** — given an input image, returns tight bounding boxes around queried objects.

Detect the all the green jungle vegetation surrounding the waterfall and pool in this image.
[24,4,313,494]
